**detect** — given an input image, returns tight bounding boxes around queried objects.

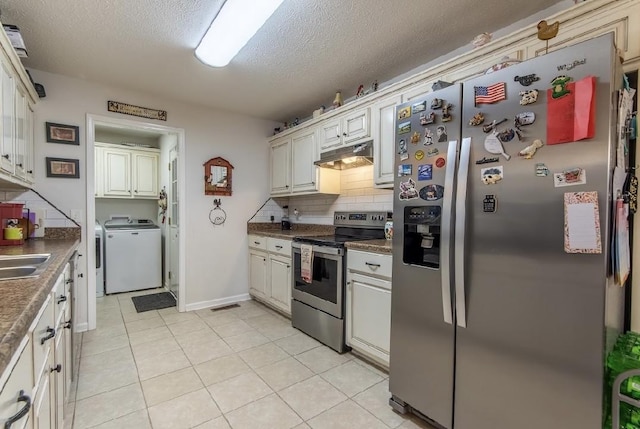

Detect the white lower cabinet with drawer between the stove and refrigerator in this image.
[346,250,392,368]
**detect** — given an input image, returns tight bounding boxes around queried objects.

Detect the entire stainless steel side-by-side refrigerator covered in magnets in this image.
[389,34,623,429]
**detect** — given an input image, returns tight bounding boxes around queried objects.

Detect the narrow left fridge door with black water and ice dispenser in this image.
[389,85,461,428]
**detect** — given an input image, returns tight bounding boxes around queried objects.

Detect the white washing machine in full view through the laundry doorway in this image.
[104,219,162,294]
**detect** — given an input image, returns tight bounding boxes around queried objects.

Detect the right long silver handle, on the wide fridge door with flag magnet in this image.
[454,137,471,328]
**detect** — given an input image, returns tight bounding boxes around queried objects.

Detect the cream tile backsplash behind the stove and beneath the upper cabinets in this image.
[249,166,393,225]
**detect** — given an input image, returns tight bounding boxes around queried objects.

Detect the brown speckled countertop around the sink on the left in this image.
[0,239,80,374]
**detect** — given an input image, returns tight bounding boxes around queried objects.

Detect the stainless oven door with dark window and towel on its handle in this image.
[291,243,344,319]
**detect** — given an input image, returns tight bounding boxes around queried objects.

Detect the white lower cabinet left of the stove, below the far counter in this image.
[249,235,292,315]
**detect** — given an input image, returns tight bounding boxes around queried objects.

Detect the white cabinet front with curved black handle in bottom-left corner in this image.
[0,342,33,429]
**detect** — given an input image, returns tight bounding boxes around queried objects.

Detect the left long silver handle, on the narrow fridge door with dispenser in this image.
[440,140,458,325]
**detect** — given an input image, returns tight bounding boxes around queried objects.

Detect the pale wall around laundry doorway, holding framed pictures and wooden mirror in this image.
[26,70,275,324]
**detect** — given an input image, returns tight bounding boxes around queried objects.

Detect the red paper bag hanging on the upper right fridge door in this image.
[547,76,595,144]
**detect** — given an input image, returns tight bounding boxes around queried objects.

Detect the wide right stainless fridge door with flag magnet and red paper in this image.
[452,35,622,429]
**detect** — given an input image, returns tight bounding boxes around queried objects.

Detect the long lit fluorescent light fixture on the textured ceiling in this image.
[196,0,284,67]
